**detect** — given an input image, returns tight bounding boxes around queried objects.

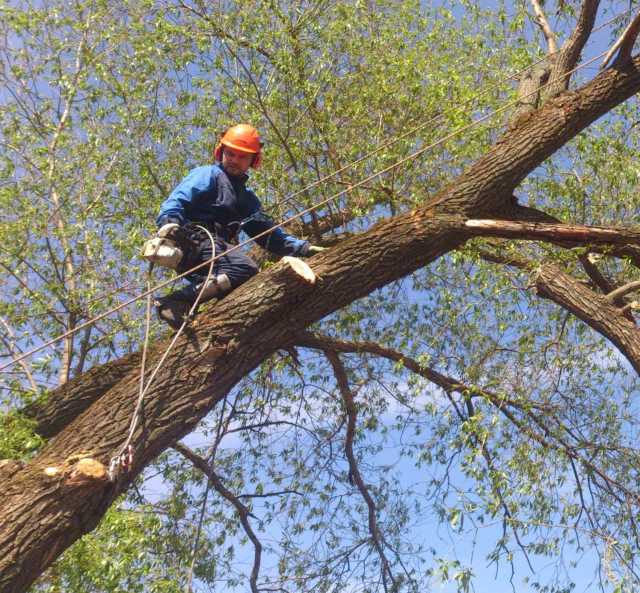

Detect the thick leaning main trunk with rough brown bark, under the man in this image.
[0,53,640,593]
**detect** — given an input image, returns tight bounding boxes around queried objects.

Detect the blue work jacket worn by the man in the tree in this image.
[156,163,309,255]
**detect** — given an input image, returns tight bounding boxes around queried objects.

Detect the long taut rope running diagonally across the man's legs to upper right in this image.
[0,38,632,372]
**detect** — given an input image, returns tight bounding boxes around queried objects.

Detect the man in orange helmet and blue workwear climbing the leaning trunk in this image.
[156,124,323,329]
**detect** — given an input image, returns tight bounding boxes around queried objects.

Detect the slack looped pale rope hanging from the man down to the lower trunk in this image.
[108,225,217,482]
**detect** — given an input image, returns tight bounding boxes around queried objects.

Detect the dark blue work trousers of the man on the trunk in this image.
[172,237,258,302]
